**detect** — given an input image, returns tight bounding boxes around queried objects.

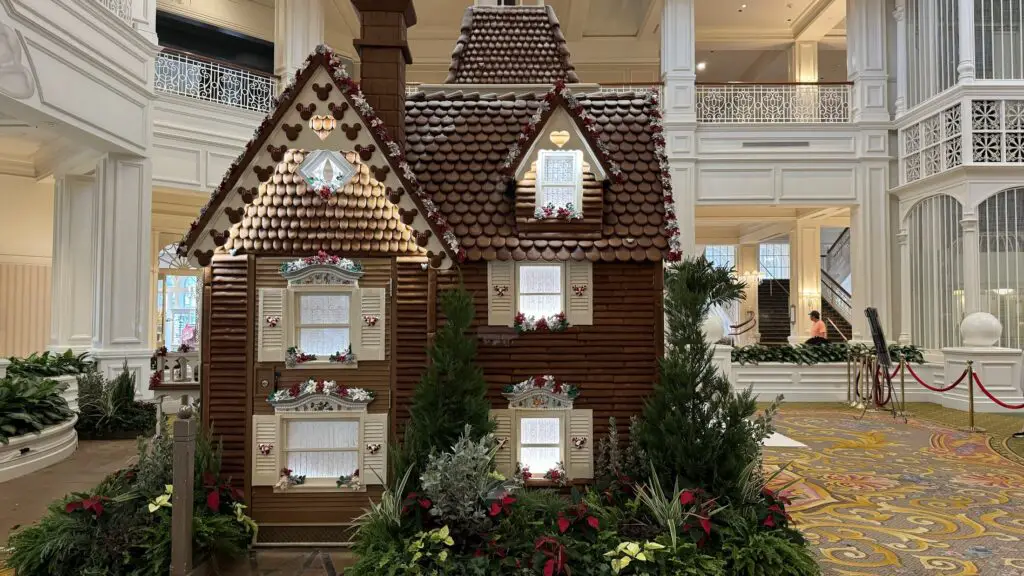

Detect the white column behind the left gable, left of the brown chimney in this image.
[273,0,325,86]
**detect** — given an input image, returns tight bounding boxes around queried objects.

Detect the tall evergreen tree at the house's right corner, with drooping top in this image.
[637,256,771,499]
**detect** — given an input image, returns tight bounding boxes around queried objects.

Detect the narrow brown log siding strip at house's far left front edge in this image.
[202,255,251,475]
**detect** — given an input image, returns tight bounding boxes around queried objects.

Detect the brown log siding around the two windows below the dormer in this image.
[430,262,662,435]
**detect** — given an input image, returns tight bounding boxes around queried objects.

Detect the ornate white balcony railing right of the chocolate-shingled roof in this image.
[696,84,851,124]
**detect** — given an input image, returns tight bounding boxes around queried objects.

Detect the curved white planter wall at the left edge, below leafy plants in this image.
[0,415,78,483]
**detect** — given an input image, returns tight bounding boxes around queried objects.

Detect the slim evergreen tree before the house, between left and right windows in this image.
[396,286,494,486]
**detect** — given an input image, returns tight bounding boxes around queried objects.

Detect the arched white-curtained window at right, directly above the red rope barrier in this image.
[906,195,964,349]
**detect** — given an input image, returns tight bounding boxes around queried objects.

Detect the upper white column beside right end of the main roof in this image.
[662,0,696,124]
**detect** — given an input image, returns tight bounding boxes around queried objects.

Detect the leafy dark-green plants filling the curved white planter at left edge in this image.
[0,375,75,444]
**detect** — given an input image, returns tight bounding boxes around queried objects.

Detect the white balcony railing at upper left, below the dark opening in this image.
[154,48,276,113]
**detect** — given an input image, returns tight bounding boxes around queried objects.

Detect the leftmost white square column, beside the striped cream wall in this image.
[49,176,99,354]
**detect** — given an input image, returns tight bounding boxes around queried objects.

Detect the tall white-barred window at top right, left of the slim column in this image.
[904,0,958,108]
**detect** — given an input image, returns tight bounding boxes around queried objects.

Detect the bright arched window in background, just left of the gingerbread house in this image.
[157,244,201,351]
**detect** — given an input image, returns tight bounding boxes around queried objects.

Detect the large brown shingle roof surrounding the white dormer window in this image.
[406,92,674,261]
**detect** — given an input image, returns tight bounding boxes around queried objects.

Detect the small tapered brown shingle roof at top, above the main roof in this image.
[444,6,580,84]
